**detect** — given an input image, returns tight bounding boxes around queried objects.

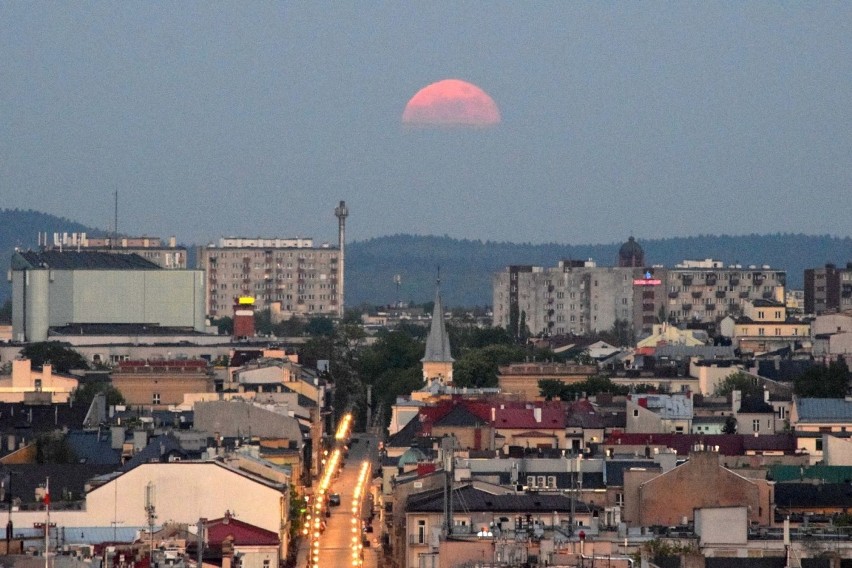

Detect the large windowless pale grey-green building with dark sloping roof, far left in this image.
[11,251,205,341]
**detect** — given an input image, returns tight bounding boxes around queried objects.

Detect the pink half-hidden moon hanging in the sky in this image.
[402,79,500,128]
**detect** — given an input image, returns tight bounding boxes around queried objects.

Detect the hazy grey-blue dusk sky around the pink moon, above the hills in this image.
[0,1,852,244]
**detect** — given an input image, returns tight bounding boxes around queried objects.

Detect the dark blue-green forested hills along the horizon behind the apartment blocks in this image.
[0,209,852,307]
